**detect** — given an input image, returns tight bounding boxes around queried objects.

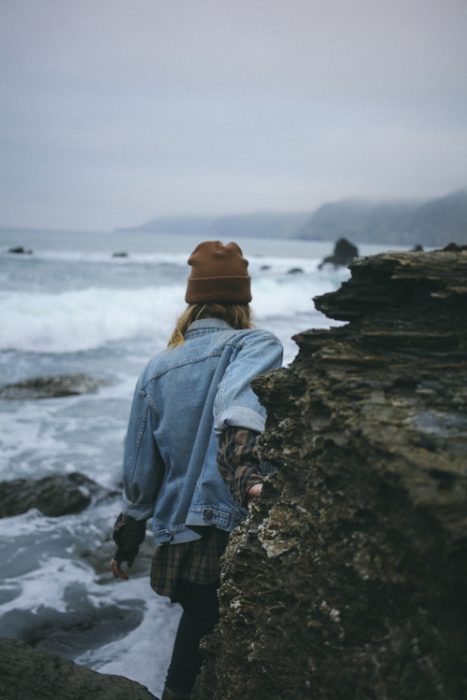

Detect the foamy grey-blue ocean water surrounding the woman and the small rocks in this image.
[0,230,398,694]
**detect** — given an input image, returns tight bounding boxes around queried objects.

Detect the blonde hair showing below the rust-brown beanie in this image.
[167,303,254,348]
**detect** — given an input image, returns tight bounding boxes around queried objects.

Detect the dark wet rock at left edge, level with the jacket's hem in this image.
[0,472,115,518]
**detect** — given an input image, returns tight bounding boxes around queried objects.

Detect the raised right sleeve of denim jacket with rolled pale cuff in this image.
[214,331,283,434]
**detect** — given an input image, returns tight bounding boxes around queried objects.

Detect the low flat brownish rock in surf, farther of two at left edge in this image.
[0,373,102,401]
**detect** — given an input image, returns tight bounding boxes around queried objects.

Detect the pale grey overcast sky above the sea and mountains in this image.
[0,0,467,230]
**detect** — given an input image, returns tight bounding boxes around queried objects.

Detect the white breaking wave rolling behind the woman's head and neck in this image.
[0,271,347,353]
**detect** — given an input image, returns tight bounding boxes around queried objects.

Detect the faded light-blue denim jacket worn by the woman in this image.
[123,319,282,546]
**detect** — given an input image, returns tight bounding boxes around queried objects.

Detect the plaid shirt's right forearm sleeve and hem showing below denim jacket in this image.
[151,427,270,602]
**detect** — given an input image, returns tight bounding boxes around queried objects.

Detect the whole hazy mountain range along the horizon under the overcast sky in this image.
[120,190,467,246]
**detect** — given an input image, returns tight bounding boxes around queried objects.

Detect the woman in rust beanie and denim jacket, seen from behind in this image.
[112,241,282,700]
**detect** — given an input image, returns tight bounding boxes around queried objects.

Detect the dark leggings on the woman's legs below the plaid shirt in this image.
[165,581,219,695]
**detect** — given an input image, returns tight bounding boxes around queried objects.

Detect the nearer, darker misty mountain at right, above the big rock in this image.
[298,190,467,246]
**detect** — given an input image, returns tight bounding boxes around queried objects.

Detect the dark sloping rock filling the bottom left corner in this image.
[0,638,157,700]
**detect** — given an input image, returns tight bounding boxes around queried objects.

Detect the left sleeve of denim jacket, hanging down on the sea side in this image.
[123,379,164,520]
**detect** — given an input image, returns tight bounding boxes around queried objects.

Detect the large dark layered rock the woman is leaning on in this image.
[196,245,467,700]
